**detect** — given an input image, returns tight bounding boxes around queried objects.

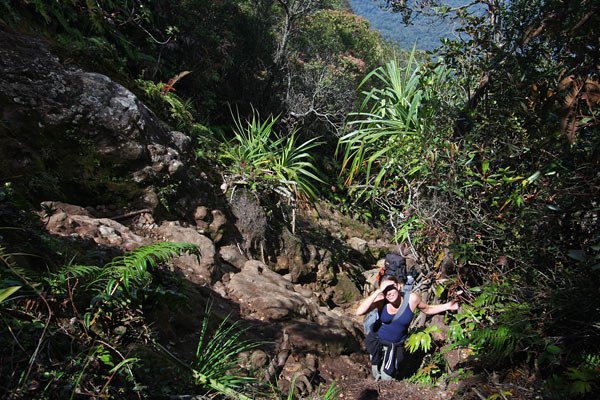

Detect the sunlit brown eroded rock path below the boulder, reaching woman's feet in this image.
[38,202,468,400]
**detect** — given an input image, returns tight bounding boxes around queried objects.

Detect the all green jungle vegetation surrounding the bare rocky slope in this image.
[0,0,600,398]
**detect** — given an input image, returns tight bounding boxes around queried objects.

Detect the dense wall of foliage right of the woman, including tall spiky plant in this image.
[340,1,600,397]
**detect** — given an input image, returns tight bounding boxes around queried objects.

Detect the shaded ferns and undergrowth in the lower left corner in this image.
[0,200,225,399]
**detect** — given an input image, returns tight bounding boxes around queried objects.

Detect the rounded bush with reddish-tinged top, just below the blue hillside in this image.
[284,10,383,138]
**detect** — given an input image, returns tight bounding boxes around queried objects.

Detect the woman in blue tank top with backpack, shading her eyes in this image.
[356,254,458,380]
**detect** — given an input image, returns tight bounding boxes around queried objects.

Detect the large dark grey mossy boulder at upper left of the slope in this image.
[0,24,201,209]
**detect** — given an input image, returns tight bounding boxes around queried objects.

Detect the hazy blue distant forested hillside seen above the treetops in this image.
[349,0,466,50]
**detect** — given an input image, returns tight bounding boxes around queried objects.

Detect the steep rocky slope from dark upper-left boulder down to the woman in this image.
[0,25,468,399]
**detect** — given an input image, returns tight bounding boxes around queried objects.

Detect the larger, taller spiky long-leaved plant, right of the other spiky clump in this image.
[337,50,460,194]
